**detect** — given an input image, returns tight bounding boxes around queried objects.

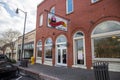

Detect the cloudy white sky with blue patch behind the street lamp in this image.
[0,0,43,33]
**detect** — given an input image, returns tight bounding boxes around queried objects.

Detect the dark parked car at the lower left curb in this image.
[0,61,19,80]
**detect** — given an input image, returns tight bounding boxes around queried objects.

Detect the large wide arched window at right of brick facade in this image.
[91,21,120,59]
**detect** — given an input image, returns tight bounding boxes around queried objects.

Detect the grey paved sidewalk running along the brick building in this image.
[17,64,120,80]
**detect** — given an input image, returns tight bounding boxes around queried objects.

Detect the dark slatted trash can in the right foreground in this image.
[93,62,110,80]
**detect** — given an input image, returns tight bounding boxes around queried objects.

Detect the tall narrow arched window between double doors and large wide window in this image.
[73,31,85,65]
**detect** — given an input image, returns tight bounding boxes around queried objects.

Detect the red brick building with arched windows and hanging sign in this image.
[35,0,120,70]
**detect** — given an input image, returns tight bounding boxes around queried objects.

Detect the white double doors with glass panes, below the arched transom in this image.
[57,47,67,66]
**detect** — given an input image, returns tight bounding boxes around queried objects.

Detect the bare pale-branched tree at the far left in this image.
[0,29,21,58]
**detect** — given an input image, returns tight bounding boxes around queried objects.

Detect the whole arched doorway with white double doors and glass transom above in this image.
[56,35,67,66]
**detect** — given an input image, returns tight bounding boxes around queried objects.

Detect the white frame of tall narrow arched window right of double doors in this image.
[73,31,87,69]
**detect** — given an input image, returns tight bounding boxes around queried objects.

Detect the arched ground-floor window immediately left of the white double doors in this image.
[45,38,52,59]
